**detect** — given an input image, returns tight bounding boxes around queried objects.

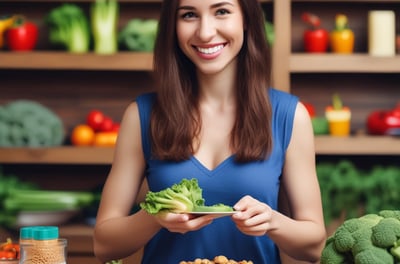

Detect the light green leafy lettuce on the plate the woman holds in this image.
[140,178,233,214]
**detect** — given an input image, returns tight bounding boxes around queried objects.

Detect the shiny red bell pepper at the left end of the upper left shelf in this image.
[6,19,39,51]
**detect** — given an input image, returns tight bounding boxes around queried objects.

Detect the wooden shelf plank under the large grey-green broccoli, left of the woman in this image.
[0,146,114,165]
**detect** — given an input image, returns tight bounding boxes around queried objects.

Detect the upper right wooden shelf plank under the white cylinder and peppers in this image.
[289,53,400,73]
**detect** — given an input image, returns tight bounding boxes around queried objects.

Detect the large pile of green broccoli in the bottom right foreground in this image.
[321,210,400,264]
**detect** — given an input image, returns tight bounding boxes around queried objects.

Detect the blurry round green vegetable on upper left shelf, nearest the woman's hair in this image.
[118,18,158,51]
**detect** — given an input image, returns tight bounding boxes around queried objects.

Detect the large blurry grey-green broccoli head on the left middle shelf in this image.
[0,100,65,147]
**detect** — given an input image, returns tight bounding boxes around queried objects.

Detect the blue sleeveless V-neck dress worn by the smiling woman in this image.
[136,89,298,264]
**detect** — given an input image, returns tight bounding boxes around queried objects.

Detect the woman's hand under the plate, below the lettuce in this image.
[155,212,214,234]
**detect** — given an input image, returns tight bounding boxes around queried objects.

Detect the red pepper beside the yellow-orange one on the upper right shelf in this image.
[303,28,329,52]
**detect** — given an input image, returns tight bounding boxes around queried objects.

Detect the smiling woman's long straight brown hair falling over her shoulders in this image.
[150,0,272,162]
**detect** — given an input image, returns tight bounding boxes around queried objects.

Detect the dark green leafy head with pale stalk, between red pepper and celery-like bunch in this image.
[45,3,90,53]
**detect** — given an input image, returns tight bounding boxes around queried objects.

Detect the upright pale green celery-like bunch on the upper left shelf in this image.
[90,0,119,54]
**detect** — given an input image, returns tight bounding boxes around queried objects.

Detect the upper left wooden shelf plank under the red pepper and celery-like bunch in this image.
[0,51,153,71]
